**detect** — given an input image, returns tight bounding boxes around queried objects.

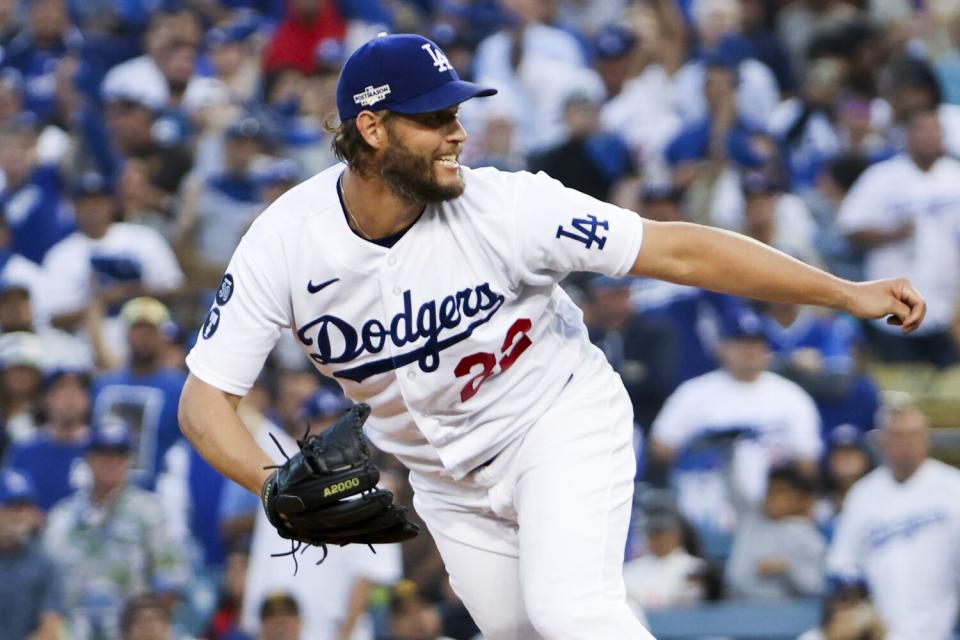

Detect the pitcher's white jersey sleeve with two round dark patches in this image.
[187,230,292,396]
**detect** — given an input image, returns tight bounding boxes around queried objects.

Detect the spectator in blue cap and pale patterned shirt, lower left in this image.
[44,422,189,638]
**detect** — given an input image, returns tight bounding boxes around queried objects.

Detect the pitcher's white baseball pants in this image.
[411,347,653,640]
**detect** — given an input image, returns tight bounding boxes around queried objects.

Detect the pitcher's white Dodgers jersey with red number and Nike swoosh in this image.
[187,165,643,479]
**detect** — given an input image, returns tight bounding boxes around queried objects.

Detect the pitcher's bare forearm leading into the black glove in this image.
[178,373,273,494]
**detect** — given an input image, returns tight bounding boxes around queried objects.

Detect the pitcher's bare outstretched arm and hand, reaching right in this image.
[630,220,927,333]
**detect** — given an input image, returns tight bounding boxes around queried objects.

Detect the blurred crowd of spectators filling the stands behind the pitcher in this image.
[0,0,960,640]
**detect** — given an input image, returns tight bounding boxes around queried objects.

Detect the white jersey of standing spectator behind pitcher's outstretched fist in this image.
[837,154,960,334]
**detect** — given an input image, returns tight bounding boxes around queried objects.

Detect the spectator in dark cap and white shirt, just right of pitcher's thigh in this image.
[623,513,706,611]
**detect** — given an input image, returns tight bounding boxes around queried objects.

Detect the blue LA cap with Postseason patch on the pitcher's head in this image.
[337,33,497,121]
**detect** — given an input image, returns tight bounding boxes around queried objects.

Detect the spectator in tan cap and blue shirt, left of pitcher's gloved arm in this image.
[92,297,186,488]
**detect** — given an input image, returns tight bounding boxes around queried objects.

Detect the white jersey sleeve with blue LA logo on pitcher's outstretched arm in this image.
[512,172,643,286]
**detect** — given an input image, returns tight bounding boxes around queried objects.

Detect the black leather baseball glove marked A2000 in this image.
[261,403,420,562]
